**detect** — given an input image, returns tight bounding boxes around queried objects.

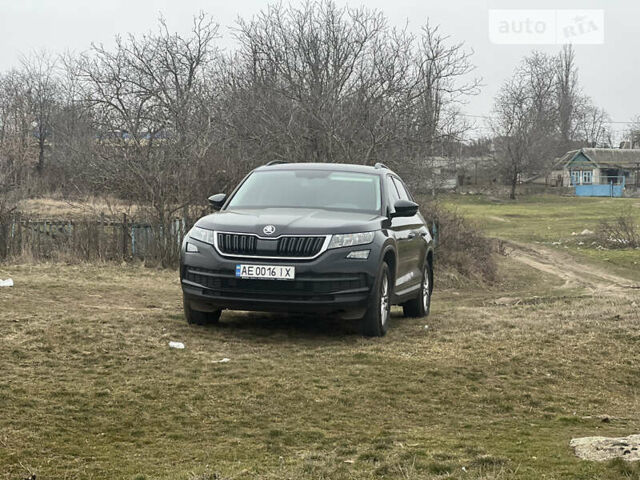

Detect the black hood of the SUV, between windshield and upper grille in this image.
[196,208,385,237]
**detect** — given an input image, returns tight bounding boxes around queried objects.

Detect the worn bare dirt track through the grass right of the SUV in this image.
[505,242,640,292]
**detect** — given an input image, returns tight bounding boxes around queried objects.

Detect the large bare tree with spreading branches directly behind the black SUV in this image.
[225,1,477,186]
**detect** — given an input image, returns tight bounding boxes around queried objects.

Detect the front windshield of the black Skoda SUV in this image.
[228,170,381,213]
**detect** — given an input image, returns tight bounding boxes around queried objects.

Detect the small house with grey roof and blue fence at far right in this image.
[554,148,640,197]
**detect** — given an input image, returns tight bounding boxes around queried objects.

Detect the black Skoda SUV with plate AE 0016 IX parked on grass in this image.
[180,162,433,336]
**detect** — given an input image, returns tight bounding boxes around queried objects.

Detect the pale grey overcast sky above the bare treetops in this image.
[0,0,640,140]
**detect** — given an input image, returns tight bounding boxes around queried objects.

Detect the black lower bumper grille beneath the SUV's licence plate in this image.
[184,267,369,300]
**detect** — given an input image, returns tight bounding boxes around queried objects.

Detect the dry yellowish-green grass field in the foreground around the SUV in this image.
[0,194,640,480]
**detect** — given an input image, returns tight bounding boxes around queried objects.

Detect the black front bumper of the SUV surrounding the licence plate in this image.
[180,239,380,318]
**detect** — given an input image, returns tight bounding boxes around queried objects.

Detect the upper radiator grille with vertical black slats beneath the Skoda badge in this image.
[217,233,325,258]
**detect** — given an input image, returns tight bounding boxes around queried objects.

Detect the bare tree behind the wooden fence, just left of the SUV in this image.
[71,14,218,262]
